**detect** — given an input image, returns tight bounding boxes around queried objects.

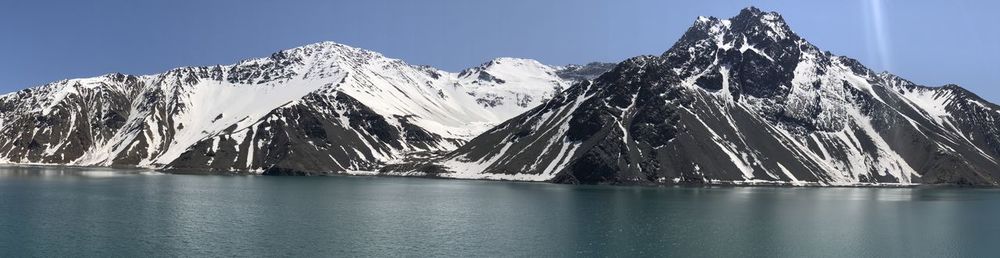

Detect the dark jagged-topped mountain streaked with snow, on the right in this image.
[426,7,1000,186]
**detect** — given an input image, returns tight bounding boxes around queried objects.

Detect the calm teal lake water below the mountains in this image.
[0,167,1000,257]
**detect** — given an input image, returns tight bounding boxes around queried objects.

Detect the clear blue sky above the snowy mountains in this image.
[0,0,1000,102]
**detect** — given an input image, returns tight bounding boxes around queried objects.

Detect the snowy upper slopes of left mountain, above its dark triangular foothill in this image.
[0,41,593,166]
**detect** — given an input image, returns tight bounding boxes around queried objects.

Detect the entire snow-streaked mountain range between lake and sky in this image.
[0,7,1000,186]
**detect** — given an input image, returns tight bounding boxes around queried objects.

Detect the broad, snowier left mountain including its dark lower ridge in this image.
[0,42,608,174]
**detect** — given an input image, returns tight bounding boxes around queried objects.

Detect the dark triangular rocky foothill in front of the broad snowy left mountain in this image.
[166,93,461,175]
